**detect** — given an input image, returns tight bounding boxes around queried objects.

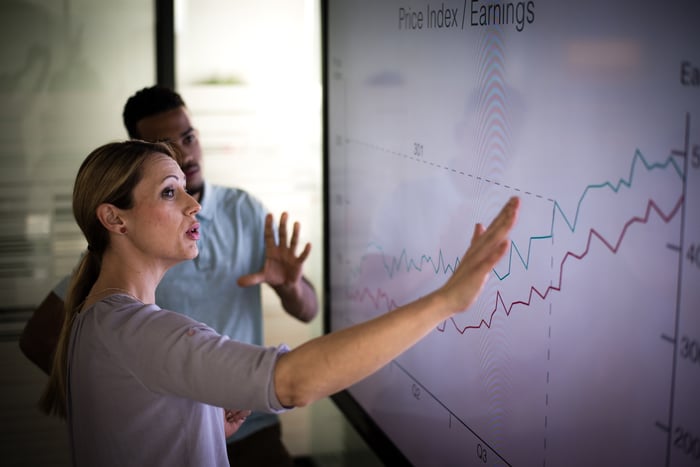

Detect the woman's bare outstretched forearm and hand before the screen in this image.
[274,198,520,407]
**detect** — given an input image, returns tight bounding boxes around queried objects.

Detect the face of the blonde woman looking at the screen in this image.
[121,153,201,265]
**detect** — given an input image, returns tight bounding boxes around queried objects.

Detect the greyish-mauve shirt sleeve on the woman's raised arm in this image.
[95,302,289,413]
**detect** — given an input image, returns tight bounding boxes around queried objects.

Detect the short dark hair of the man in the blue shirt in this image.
[122,84,185,139]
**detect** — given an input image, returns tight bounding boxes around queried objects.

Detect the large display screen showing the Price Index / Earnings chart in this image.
[322,0,700,466]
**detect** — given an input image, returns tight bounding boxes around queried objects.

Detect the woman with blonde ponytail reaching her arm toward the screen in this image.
[42,141,519,466]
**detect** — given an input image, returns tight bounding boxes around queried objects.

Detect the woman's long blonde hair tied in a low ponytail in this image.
[39,140,182,418]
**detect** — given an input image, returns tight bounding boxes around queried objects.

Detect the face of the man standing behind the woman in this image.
[136,107,204,199]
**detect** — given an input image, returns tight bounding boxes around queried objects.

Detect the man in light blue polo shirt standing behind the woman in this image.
[20,86,318,466]
